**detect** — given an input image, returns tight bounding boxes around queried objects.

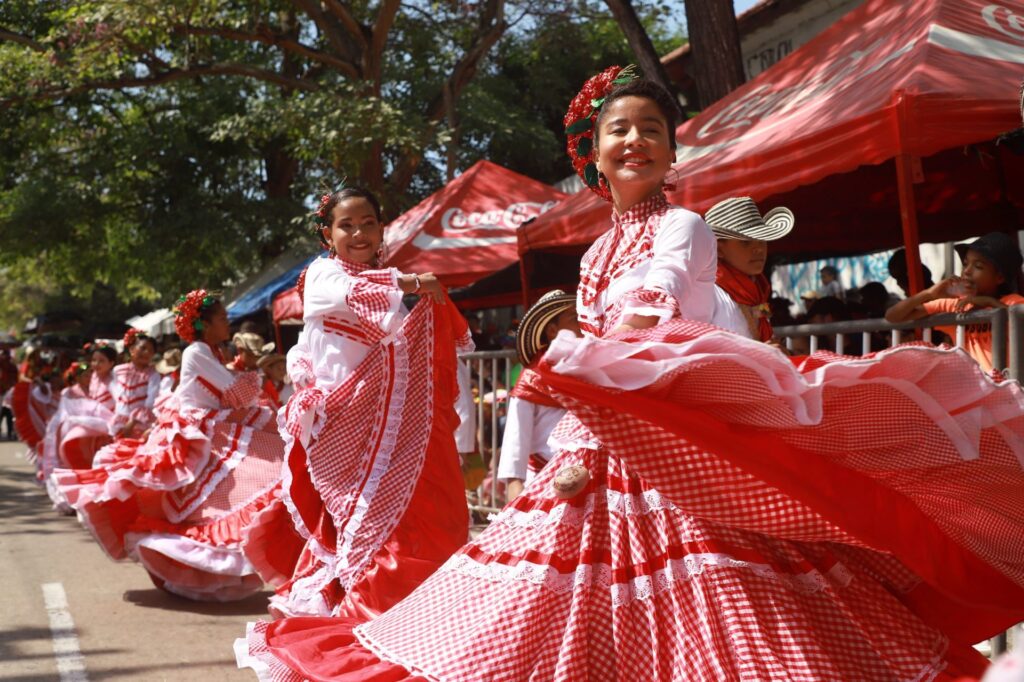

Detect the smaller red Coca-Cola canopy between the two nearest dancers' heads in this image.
[384,161,566,287]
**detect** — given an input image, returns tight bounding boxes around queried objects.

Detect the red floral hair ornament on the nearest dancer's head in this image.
[562,63,640,202]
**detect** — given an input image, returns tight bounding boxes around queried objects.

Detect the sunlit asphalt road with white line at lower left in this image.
[0,441,268,682]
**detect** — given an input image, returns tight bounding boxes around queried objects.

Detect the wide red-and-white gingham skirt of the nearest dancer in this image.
[237,193,1024,681]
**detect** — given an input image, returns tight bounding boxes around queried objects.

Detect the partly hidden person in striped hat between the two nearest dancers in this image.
[498,289,581,502]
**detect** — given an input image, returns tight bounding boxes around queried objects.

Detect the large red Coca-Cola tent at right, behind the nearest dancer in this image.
[519,0,1024,296]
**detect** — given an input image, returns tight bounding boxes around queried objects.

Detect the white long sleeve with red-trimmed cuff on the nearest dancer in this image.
[623,209,718,323]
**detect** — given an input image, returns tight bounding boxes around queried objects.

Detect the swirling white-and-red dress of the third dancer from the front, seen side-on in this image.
[52,342,283,601]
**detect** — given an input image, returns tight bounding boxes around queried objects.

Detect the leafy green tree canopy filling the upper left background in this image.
[0,0,678,324]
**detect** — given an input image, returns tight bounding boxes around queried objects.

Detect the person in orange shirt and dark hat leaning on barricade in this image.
[886,232,1024,372]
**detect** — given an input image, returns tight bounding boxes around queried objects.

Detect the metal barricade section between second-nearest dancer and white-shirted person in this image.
[459,350,518,524]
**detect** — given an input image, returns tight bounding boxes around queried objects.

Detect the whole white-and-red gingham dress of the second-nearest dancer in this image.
[238,258,471,620]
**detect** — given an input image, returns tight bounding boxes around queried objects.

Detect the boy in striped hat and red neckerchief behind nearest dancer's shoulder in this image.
[705,197,795,341]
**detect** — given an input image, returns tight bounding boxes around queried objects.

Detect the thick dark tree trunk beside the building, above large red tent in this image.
[686,0,746,109]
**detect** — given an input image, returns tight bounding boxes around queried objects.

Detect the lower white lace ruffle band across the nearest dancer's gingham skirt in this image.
[440,553,853,607]
